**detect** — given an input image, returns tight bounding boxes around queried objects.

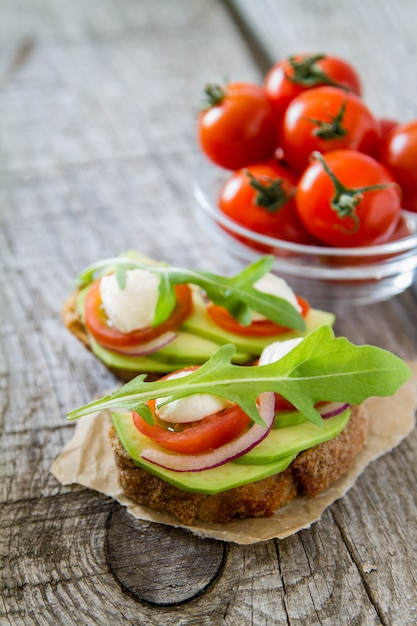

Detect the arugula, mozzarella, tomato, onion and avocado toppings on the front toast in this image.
[69,326,410,491]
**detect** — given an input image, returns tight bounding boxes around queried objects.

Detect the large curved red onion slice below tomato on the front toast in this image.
[141,391,275,472]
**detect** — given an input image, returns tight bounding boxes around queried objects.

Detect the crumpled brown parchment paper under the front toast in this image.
[51,362,417,544]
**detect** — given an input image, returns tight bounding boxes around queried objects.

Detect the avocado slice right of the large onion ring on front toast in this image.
[235,409,351,465]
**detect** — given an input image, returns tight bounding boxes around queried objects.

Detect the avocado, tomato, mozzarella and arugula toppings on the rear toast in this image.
[71,252,334,375]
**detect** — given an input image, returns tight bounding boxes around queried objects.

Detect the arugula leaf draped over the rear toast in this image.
[76,255,305,330]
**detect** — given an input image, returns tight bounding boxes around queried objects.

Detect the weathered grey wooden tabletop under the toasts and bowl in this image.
[0,0,417,626]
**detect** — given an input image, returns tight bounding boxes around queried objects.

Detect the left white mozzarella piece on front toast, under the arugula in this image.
[155,371,230,424]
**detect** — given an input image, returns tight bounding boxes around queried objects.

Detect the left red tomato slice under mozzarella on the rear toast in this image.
[84,280,192,350]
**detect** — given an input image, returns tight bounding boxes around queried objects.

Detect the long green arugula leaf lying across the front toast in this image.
[68,326,411,425]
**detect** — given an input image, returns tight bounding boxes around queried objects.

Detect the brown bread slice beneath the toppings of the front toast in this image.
[109,406,368,525]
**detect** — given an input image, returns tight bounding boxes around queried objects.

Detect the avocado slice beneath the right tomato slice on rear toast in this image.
[182,288,335,356]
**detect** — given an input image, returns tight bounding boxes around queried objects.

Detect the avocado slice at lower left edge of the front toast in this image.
[112,413,294,494]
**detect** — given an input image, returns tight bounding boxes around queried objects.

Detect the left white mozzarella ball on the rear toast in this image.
[100,269,160,333]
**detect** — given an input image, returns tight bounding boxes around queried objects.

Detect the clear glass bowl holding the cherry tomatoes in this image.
[193,159,417,310]
